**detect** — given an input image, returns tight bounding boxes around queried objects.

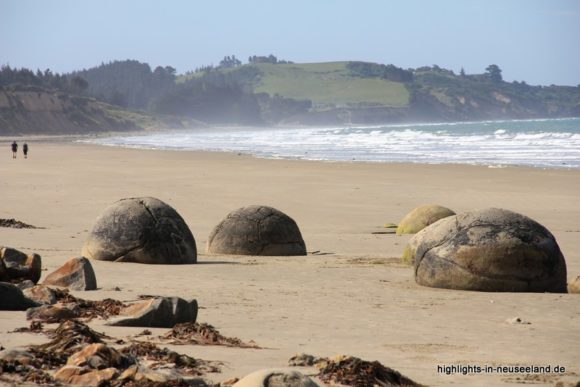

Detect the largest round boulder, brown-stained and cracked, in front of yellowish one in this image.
[414,208,566,293]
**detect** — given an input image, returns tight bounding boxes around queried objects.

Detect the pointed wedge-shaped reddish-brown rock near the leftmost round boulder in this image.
[43,257,97,290]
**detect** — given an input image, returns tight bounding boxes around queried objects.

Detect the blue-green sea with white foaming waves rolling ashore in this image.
[83,118,580,168]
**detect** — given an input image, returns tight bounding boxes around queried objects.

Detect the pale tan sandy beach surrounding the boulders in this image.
[0,142,580,386]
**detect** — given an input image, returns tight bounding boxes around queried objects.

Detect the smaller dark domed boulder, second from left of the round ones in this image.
[207,206,306,256]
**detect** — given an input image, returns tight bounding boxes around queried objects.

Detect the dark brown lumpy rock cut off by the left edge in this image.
[0,247,42,283]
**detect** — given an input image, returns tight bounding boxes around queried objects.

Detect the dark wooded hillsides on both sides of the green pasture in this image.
[0,54,580,124]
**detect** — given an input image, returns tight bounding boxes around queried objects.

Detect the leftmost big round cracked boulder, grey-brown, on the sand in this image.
[82,197,197,264]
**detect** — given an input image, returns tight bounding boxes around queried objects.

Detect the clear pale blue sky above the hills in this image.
[0,0,580,86]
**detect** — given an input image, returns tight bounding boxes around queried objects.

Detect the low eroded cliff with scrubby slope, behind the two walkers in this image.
[0,87,140,136]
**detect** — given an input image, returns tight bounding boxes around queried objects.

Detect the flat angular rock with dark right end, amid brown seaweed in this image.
[107,297,198,328]
